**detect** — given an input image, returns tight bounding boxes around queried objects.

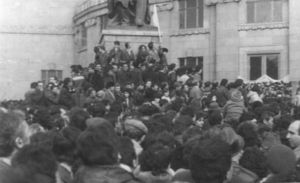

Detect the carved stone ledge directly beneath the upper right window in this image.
[238,22,289,31]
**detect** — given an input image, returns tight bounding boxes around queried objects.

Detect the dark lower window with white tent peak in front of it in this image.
[249,54,280,80]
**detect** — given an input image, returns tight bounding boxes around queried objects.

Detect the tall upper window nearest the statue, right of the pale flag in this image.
[179,0,204,29]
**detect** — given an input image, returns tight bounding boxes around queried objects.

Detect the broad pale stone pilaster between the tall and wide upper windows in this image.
[206,0,239,80]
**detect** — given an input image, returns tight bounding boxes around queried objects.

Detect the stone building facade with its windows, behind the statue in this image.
[73,0,300,81]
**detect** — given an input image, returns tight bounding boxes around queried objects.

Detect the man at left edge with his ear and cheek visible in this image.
[0,112,30,180]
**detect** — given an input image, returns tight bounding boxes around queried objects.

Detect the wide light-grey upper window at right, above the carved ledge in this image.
[247,0,283,23]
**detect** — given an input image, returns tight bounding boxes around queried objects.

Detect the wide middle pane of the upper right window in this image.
[256,1,272,22]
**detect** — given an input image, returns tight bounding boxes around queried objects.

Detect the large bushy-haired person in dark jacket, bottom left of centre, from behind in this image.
[74,124,140,183]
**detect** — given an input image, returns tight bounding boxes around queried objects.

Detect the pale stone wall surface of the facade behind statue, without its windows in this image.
[75,0,300,80]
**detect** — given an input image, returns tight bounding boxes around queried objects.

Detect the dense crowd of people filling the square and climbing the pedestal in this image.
[0,41,300,183]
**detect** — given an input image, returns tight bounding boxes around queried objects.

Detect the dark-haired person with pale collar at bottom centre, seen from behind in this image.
[134,143,174,183]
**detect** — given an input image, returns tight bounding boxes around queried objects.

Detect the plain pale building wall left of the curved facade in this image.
[0,0,82,100]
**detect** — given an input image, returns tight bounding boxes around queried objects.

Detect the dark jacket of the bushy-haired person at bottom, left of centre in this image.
[74,165,139,183]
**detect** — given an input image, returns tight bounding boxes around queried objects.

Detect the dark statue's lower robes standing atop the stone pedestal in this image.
[107,0,151,27]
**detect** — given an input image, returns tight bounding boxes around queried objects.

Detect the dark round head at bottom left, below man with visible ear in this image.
[12,145,57,183]
